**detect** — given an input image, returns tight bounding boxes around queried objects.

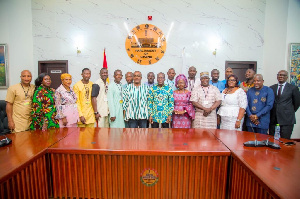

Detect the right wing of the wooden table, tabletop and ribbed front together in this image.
[211,130,300,199]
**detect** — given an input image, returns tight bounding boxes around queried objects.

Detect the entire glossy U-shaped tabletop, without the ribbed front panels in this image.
[0,128,300,198]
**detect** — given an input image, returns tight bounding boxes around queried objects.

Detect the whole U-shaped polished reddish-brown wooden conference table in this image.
[0,128,300,198]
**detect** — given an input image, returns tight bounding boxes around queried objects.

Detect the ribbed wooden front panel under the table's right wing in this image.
[228,158,278,199]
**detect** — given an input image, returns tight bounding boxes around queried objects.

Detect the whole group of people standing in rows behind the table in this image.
[6,66,300,139]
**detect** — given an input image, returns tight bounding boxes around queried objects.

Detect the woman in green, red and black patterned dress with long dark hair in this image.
[30,73,59,131]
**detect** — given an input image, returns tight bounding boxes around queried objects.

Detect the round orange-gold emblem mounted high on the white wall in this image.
[125,24,167,65]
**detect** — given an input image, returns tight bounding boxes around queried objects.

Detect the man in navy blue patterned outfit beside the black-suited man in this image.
[246,74,275,134]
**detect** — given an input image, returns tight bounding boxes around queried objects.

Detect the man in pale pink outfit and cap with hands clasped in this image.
[190,72,222,129]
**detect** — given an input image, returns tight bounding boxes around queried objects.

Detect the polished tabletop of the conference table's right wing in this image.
[211,130,300,198]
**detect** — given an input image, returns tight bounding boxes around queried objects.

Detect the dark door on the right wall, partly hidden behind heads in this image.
[225,61,257,82]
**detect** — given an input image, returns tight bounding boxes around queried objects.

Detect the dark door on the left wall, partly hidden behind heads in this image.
[38,60,68,89]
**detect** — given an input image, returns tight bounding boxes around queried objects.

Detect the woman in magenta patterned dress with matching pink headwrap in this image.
[172,74,195,128]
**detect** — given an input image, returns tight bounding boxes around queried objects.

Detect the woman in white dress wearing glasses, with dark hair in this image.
[218,75,248,131]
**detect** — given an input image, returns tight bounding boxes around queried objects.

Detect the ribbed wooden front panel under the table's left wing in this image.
[0,156,48,199]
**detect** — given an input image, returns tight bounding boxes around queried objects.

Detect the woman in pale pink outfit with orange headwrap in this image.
[55,73,79,128]
